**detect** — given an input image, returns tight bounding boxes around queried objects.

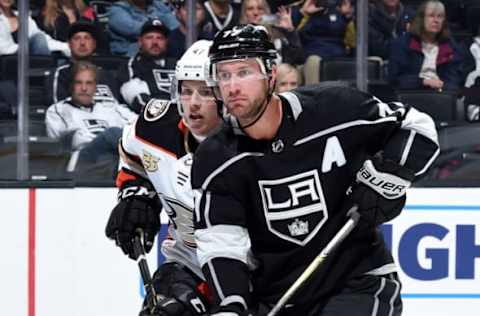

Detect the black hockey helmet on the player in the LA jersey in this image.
[209,24,277,76]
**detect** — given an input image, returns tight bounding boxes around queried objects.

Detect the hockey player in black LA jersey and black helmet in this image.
[192,25,439,316]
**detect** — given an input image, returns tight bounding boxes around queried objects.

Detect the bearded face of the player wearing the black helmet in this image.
[216,58,268,122]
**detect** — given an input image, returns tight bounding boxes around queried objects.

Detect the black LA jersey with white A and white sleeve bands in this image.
[192,86,438,312]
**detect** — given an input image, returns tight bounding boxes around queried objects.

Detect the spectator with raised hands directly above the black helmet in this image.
[240,0,304,65]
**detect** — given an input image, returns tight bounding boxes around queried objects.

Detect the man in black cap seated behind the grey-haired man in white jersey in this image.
[50,21,119,103]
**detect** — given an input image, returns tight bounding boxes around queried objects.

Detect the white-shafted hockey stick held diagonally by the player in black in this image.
[267,205,360,316]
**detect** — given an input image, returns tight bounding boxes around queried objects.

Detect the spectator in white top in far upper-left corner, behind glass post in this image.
[0,0,70,56]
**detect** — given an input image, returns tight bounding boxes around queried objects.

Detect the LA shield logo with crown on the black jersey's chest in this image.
[258,170,328,246]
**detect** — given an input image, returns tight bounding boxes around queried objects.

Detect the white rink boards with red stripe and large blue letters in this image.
[0,188,480,316]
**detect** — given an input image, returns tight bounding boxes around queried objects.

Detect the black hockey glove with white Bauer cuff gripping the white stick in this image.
[344,159,415,227]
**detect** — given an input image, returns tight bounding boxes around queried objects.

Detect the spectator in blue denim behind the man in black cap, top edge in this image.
[108,0,179,57]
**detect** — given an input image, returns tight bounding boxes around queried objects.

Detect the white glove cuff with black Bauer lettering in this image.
[357,160,411,200]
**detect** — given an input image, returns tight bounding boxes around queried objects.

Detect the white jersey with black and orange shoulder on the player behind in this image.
[120,99,203,279]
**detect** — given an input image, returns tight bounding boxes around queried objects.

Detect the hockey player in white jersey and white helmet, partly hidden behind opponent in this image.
[106,40,222,316]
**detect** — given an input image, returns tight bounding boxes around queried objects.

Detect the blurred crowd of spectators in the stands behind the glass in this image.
[0,0,480,181]
